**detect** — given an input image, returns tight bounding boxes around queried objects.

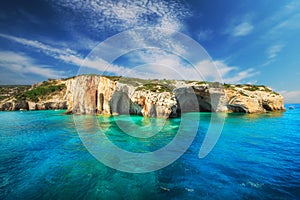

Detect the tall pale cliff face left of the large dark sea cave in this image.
[67,76,176,117]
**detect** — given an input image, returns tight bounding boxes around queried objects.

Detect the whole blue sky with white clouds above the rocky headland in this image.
[0,0,300,103]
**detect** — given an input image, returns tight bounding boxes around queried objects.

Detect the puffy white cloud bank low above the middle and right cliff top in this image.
[102,49,258,83]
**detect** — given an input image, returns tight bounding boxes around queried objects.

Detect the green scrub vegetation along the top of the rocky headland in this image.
[0,74,279,102]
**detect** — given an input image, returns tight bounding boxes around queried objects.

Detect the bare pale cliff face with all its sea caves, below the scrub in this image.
[68,76,284,117]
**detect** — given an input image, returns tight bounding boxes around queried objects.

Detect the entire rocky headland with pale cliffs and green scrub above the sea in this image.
[0,75,284,117]
